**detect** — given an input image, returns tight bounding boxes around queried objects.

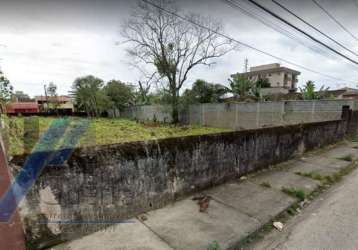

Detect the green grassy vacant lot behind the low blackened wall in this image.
[5,117,229,155]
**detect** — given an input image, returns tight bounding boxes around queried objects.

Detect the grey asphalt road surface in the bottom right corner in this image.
[251,170,358,250]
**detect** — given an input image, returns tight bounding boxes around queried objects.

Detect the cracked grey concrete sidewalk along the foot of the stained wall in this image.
[53,142,358,250]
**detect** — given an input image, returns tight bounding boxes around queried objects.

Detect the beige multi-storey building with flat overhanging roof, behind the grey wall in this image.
[237,63,301,95]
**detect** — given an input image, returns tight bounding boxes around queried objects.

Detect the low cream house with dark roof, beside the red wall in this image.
[35,96,74,115]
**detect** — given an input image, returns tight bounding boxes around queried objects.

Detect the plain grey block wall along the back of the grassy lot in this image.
[112,100,358,130]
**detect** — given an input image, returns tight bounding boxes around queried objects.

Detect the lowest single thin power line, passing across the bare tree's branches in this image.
[142,0,357,83]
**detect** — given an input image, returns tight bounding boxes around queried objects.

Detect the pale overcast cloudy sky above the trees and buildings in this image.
[0,0,358,95]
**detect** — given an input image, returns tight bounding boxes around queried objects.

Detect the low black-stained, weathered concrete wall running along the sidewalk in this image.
[13,117,357,248]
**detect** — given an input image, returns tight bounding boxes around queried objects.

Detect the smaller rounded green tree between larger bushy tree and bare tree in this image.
[104,80,135,110]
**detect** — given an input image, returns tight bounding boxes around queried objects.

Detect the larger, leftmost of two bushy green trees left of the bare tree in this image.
[71,75,112,116]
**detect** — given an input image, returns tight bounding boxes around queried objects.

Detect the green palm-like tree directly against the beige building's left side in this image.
[229,74,254,98]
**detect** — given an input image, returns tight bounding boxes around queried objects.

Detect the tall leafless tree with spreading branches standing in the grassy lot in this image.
[122,0,234,123]
